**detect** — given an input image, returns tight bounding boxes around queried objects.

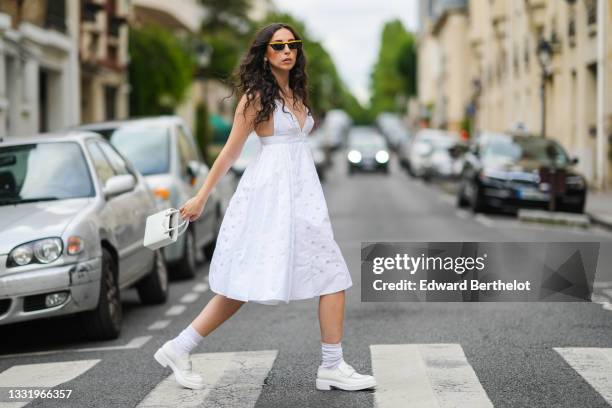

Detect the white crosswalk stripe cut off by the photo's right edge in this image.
[553,347,612,405]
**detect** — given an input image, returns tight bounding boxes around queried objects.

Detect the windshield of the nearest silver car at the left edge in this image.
[0,142,95,205]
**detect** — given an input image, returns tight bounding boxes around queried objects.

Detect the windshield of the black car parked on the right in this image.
[483,136,570,166]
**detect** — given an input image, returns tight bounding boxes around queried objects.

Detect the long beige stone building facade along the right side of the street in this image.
[419,0,612,188]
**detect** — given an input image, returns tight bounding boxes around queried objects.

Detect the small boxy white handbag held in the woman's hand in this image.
[142,208,189,250]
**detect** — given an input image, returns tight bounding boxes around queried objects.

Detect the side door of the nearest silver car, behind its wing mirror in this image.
[97,141,156,279]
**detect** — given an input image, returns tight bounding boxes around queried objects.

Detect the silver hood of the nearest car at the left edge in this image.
[0,197,93,255]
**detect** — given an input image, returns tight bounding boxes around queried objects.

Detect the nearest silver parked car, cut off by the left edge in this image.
[0,132,168,339]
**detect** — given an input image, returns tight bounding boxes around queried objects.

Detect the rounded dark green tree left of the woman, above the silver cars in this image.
[129,26,195,116]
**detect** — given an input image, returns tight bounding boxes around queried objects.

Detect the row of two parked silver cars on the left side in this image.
[0,117,225,339]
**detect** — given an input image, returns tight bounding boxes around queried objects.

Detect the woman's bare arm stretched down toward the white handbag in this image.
[180,95,258,221]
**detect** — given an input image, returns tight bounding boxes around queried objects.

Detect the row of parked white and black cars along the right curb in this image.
[398,129,587,217]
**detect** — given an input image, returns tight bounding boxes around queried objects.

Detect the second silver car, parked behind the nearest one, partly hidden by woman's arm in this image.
[78,116,231,278]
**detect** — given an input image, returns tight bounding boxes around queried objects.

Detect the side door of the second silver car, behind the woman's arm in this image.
[176,125,216,246]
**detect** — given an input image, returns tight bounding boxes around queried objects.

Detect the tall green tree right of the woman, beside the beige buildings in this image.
[370,20,416,116]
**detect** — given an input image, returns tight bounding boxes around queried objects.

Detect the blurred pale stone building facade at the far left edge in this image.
[0,0,80,137]
